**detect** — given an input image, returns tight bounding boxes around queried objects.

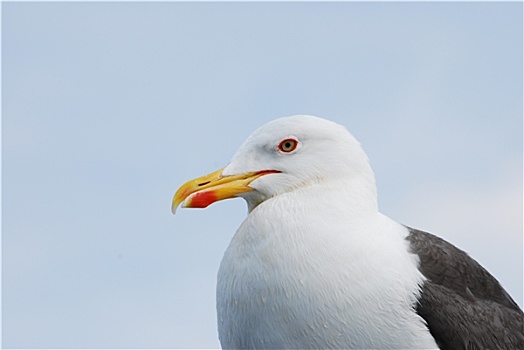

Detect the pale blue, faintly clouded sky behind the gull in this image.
[2,2,523,348]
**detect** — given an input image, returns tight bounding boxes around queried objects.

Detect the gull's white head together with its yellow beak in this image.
[173,115,376,210]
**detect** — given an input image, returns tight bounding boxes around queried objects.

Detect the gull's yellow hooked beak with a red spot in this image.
[171,168,279,214]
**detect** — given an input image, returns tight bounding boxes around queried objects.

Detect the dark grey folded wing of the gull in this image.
[406,227,524,349]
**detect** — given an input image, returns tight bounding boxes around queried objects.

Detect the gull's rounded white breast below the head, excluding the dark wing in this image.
[213,185,437,349]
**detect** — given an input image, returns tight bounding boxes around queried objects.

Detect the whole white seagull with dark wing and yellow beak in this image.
[172,115,524,349]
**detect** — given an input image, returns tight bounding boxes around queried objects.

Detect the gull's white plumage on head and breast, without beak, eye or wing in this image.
[217,116,437,349]
